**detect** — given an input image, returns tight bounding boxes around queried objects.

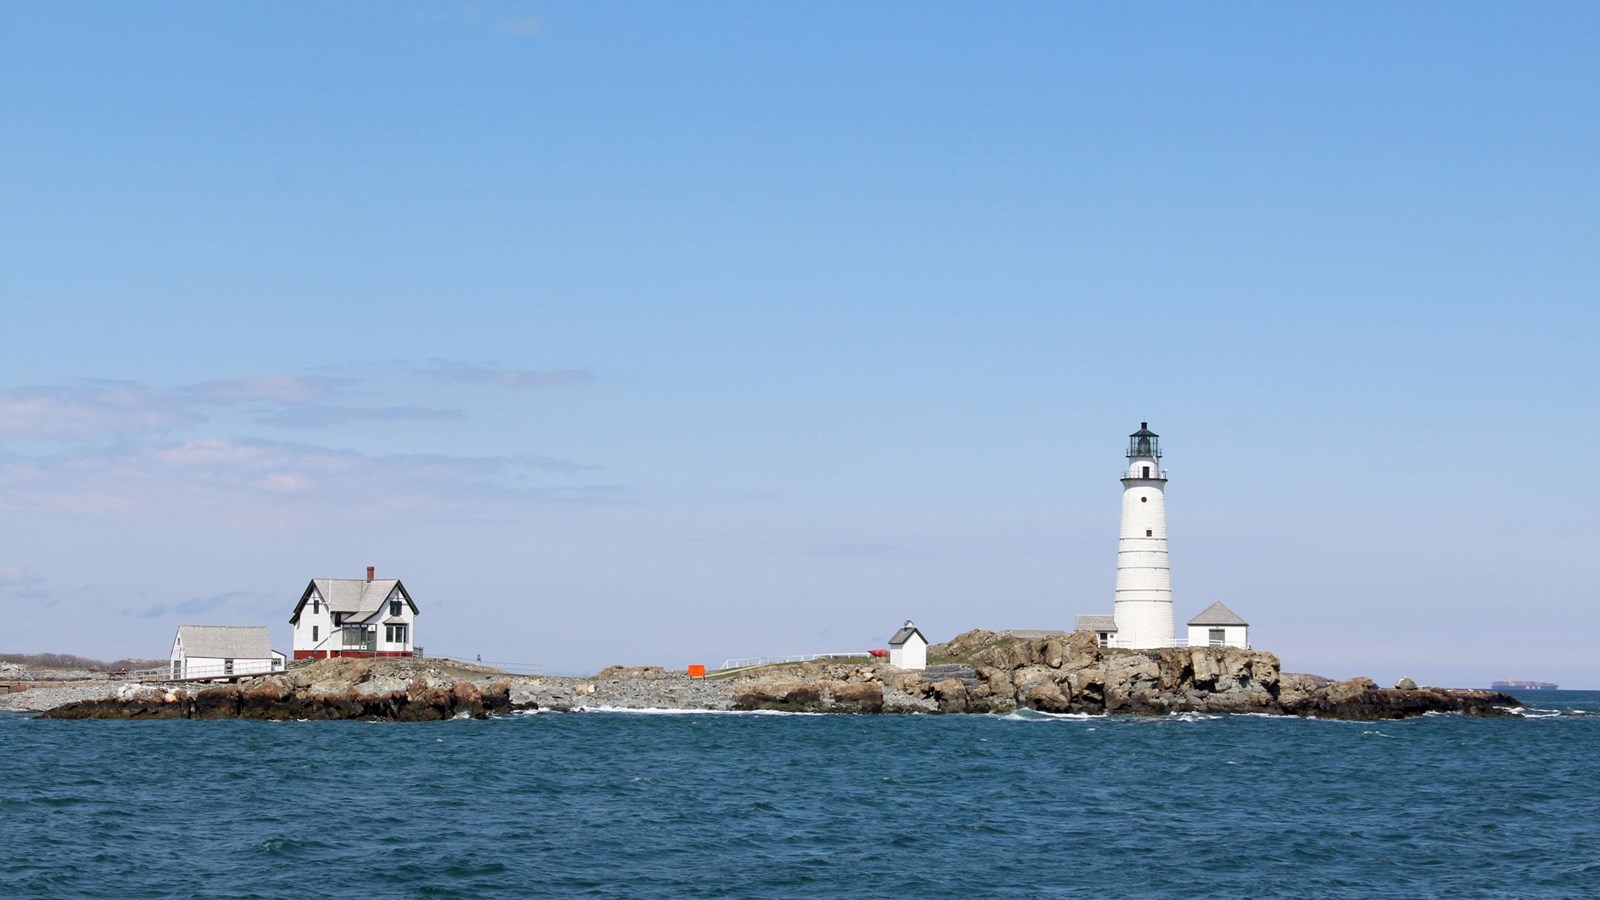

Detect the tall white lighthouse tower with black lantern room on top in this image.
[1112,421,1174,649]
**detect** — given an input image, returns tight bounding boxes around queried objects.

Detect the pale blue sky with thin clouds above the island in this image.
[0,2,1600,687]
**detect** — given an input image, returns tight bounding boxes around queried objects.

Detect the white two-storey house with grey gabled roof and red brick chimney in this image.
[290,565,422,660]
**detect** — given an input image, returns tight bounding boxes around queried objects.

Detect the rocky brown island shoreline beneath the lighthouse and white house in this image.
[28,631,1522,722]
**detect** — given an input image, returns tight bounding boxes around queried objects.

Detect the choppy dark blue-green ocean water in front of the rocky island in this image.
[0,690,1600,900]
